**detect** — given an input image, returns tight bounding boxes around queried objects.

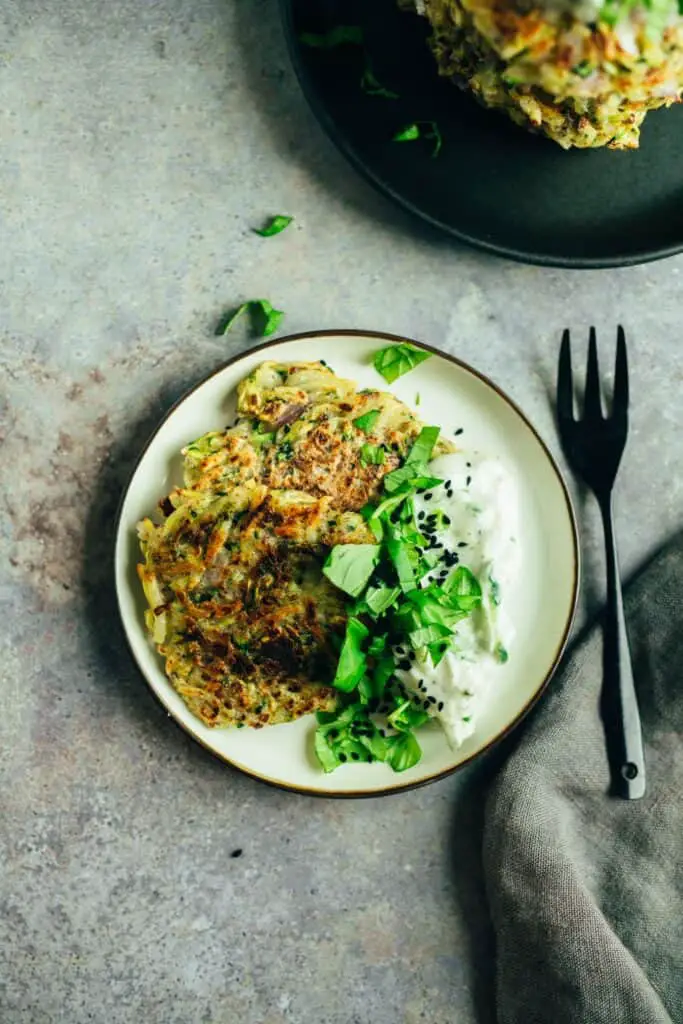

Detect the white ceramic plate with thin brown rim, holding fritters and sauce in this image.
[116,331,579,796]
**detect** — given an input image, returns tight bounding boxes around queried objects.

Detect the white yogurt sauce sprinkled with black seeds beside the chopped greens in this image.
[395,452,520,746]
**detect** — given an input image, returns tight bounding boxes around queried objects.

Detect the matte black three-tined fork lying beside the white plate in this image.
[557,327,645,800]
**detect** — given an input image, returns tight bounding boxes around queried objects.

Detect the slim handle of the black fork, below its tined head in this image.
[600,495,645,800]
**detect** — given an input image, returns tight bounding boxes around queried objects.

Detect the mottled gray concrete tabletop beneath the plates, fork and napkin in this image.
[0,0,683,1024]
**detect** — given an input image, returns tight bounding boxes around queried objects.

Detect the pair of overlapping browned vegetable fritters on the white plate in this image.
[138,362,451,728]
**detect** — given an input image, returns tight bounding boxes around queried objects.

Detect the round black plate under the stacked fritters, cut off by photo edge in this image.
[281,0,683,267]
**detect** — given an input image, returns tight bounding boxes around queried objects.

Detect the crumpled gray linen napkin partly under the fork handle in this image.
[484,537,683,1024]
